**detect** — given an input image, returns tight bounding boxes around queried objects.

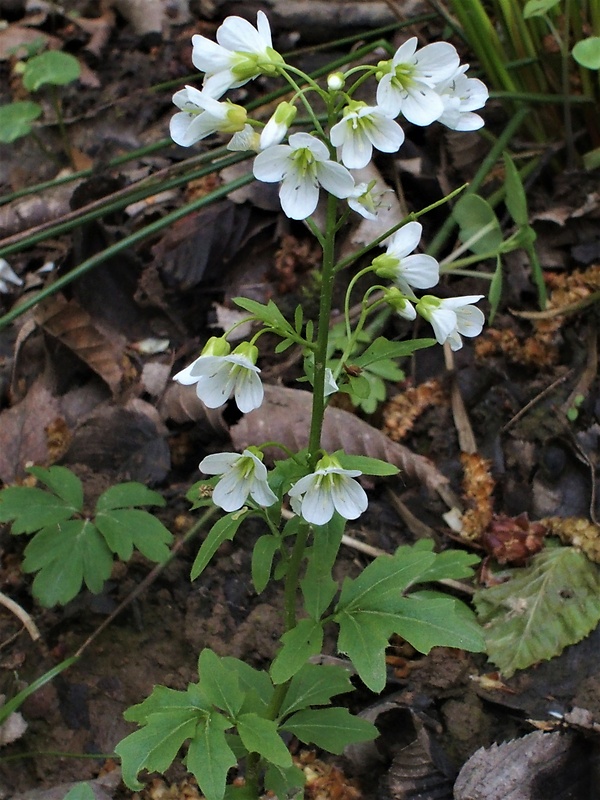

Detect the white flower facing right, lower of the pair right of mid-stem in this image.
[417,294,485,350]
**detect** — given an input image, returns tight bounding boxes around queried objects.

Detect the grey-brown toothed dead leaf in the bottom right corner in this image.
[454,731,594,800]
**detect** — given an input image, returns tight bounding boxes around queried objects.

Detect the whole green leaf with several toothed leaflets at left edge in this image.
[0,467,172,606]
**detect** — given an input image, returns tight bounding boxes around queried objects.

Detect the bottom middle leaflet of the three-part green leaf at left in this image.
[23,520,113,607]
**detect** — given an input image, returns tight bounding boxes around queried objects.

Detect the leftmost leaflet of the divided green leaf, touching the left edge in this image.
[0,486,77,535]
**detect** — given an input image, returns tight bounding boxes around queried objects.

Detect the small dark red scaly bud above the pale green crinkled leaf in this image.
[480,513,548,567]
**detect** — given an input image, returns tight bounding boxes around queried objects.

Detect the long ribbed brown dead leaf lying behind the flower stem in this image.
[231,386,450,498]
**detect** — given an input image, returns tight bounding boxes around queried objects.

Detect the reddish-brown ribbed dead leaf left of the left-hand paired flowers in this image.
[35,295,125,394]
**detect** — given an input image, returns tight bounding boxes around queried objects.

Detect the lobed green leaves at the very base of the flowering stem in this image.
[116,650,370,800]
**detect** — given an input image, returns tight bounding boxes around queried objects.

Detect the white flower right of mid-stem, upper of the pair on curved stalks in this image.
[373,222,440,300]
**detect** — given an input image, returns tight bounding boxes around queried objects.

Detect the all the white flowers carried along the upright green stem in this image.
[171,11,488,525]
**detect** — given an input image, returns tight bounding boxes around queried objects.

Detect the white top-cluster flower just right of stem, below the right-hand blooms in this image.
[329,100,404,169]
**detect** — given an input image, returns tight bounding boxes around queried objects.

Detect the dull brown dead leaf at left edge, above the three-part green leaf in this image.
[0,379,60,483]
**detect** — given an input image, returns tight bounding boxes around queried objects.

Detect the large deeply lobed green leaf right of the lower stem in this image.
[334,543,485,692]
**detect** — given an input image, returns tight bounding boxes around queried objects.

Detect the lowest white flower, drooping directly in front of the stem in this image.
[288,456,368,525]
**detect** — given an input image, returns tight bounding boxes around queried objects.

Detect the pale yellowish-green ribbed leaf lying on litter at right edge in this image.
[474,547,600,678]
